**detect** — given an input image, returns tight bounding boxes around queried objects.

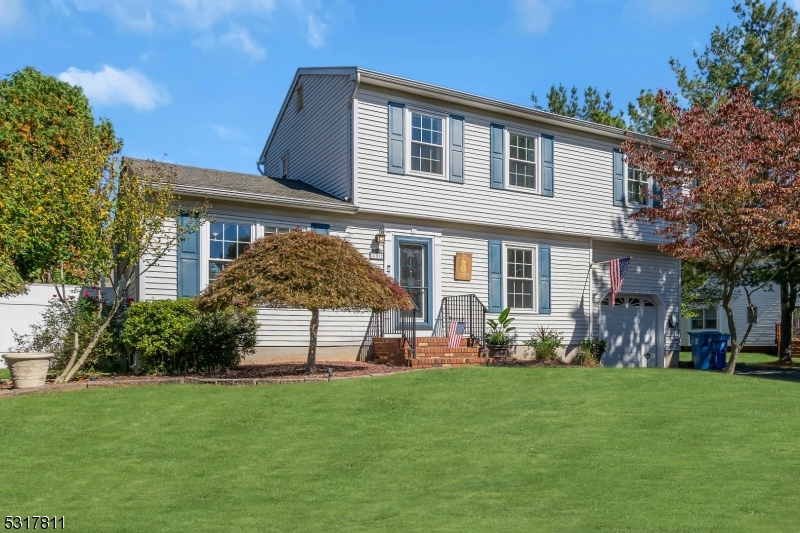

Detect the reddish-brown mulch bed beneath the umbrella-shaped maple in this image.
[0,361,411,391]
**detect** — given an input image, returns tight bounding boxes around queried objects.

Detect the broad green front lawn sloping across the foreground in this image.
[0,367,800,532]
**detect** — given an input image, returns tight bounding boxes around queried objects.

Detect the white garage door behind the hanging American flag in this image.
[600,294,658,367]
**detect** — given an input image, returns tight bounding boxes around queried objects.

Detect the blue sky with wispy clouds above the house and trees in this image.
[0,0,780,173]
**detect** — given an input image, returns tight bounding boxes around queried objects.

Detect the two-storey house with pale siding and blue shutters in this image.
[128,67,680,367]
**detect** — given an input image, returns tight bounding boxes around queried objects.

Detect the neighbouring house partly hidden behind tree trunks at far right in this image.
[681,284,800,353]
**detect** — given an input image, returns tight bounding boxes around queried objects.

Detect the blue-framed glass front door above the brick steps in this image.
[396,237,432,325]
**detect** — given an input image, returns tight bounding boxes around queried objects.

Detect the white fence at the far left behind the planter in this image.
[0,283,78,367]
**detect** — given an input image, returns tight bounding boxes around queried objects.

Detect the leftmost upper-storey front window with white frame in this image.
[407,107,447,178]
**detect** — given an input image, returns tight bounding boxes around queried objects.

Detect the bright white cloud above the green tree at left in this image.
[58,65,170,111]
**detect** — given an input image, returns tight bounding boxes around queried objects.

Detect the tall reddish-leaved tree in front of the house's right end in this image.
[622,88,800,374]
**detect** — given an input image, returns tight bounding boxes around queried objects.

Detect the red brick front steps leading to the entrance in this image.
[372,337,490,368]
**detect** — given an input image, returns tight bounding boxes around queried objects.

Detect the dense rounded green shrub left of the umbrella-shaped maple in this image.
[121,298,258,373]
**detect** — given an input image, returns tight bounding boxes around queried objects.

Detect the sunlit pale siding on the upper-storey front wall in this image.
[355,86,657,242]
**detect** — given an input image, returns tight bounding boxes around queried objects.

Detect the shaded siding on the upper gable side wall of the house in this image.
[264,75,353,198]
